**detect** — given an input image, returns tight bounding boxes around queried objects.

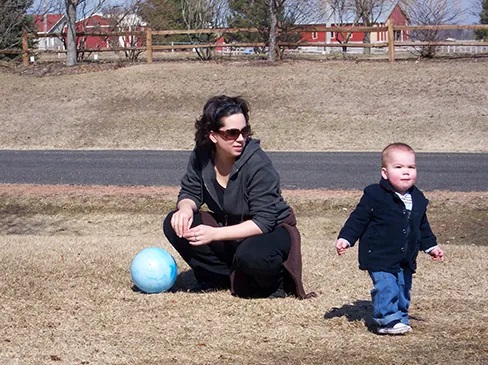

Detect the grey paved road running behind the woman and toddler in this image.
[0,150,488,191]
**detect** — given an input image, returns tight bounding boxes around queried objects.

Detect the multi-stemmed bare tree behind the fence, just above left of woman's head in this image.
[181,0,228,60]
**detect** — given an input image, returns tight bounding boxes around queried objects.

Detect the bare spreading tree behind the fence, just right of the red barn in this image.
[401,0,463,58]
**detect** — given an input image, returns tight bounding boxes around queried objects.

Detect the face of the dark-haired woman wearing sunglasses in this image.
[210,113,250,158]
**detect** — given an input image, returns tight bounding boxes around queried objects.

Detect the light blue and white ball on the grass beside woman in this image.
[130,247,178,294]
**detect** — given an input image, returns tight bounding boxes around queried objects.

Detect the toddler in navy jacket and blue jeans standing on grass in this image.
[336,143,444,335]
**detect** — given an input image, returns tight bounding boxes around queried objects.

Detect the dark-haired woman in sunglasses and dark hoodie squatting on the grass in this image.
[163,95,310,298]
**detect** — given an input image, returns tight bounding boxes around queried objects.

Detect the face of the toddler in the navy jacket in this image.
[381,149,417,194]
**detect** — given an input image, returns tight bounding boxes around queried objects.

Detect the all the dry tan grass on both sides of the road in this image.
[0,60,488,365]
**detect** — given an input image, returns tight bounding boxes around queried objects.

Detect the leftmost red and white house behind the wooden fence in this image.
[32,14,66,50]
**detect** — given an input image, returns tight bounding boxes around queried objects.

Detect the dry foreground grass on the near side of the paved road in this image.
[0,185,488,365]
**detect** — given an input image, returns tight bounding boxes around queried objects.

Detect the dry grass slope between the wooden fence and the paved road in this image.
[0,59,488,152]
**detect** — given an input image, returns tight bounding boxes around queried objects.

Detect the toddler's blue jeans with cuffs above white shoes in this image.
[369,269,412,326]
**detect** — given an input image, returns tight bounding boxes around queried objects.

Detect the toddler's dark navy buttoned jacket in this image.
[339,179,437,273]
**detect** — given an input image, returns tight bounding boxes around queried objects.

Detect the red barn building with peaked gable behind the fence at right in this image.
[301,3,408,43]
